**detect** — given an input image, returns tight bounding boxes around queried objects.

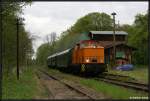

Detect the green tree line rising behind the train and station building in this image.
[36,12,148,65]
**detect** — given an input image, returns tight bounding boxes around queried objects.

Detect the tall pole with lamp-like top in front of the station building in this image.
[111,12,116,66]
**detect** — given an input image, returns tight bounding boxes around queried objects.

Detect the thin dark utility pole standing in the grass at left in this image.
[16,18,22,80]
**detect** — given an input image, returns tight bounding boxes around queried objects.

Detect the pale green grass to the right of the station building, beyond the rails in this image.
[109,66,148,83]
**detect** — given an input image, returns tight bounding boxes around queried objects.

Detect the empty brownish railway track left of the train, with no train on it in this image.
[36,70,105,100]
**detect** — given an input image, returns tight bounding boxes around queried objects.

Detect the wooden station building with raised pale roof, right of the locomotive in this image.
[88,31,136,65]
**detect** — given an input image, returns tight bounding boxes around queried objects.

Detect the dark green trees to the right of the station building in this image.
[121,14,148,65]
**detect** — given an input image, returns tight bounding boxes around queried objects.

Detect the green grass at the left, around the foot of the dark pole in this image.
[2,68,37,99]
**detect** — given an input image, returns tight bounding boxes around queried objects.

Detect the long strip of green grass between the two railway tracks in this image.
[48,69,148,99]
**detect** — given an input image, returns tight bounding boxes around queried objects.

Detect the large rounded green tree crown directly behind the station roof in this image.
[71,12,112,33]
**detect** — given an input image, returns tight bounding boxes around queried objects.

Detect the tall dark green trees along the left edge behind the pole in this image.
[1,0,33,73]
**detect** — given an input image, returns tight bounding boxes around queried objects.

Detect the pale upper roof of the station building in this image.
[90,31,128,35]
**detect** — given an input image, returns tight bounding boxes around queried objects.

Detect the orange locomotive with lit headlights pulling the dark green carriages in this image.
[72,40,106,73]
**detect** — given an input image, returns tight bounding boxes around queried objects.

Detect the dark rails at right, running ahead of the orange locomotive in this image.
[95,74,149,92]
